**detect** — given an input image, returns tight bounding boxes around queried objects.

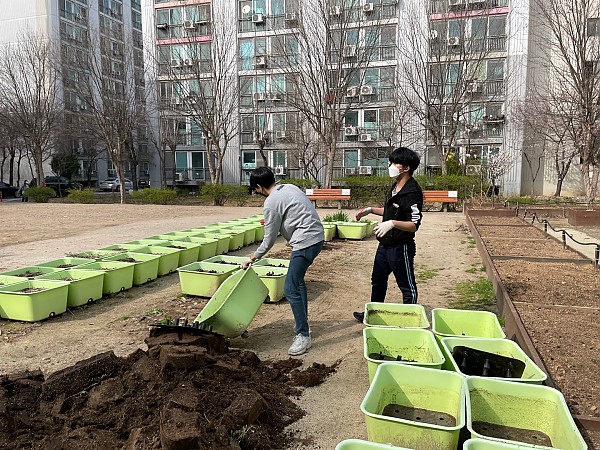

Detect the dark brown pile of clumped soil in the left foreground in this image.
[0,328,337,450]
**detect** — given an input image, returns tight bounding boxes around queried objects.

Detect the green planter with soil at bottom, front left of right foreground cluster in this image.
[360,362,465,450]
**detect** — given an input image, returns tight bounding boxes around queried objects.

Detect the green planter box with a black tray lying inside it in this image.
[442,337,547,384]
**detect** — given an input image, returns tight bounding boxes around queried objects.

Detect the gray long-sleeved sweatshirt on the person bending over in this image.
[254,184,325,258]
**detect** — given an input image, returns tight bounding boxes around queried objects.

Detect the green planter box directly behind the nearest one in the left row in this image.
[36,269,104,308]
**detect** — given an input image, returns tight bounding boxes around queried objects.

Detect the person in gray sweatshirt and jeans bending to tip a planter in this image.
[242,167,325,356]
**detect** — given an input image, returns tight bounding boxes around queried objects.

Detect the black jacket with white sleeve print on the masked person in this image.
[377,177,423,247]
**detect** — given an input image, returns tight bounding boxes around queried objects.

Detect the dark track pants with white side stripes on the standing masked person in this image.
[371,241,419,303]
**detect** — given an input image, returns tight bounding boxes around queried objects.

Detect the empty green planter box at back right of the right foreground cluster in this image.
[431,308,506,342]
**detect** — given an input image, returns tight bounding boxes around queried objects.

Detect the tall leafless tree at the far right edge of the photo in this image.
[533,0,600,209]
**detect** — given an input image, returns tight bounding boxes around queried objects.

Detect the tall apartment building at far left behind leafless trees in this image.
[0,0,153,186]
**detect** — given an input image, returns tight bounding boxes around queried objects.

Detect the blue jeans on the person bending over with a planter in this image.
[283,241,323,336]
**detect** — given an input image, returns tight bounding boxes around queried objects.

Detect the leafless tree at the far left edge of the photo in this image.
[0,33,62,185]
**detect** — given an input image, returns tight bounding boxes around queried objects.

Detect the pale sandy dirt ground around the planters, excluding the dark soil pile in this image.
[0,203,481,450]
